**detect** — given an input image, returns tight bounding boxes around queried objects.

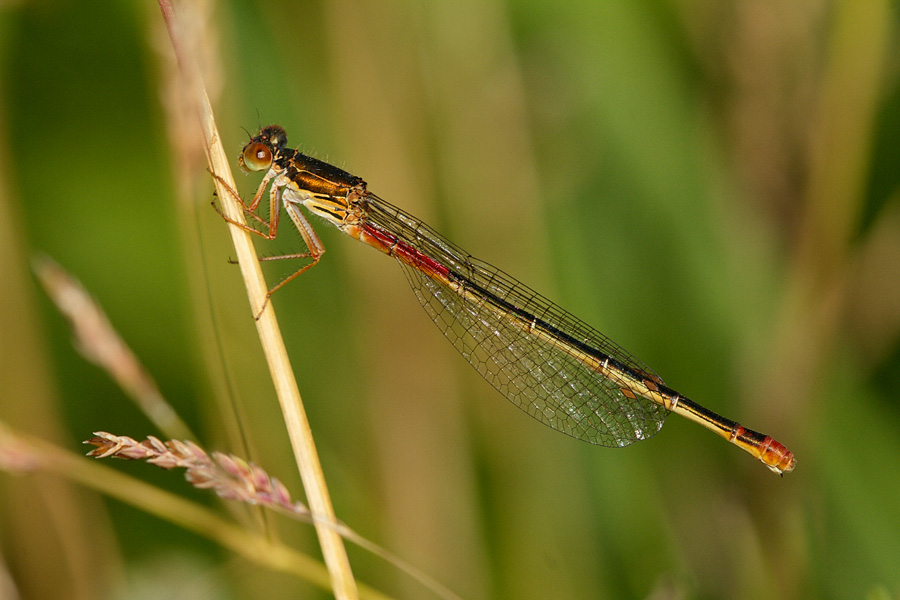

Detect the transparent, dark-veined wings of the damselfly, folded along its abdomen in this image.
[367,195,667,447]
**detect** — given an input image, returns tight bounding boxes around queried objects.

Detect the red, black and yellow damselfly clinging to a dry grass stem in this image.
[217,125,796,474]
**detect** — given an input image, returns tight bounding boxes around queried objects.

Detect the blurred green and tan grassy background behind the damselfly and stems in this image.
[0,0,900,599]
